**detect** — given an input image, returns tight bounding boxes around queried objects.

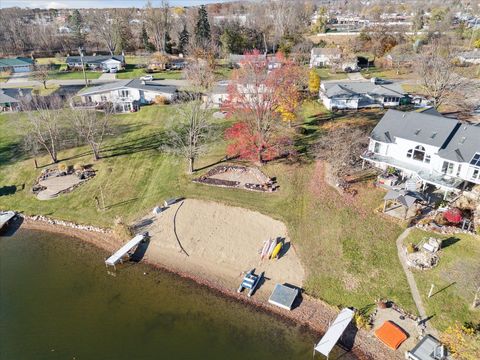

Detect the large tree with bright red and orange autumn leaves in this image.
[223,50,298,165]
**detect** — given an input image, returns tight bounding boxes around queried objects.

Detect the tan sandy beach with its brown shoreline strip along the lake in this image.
[15,199,403,360]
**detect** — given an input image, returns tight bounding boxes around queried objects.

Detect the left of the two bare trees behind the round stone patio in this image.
[22,96,66,163]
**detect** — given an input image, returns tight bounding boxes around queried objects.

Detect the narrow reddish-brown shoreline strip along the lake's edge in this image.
[17,214,403,360]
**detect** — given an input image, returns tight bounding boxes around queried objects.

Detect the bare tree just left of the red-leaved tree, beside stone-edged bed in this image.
[167,95,213,174]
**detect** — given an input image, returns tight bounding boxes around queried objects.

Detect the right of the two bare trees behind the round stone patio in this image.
[69,106,112,161]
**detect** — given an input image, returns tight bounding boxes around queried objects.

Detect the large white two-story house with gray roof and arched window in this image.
[362,110,480,195]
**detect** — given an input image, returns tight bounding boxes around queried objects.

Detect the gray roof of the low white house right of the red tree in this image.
[323,81,406,98]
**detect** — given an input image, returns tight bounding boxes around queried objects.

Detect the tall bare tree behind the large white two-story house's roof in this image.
[417,40,472,109]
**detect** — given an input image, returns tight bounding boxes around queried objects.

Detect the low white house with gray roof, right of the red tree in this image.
[320,79,409,110]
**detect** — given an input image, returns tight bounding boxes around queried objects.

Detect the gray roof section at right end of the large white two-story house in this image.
[438,124,480,163]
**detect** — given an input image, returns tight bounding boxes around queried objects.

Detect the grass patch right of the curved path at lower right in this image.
[405,230,480,330]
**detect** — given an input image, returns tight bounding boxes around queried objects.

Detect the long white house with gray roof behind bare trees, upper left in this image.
[78,79,177,112]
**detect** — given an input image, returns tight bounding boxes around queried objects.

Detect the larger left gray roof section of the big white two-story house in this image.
[371,110,459,148]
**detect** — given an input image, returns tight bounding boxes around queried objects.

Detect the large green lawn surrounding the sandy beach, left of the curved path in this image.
[0,102,415,312]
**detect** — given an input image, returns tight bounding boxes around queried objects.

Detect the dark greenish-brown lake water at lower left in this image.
[0,229,352,360]
